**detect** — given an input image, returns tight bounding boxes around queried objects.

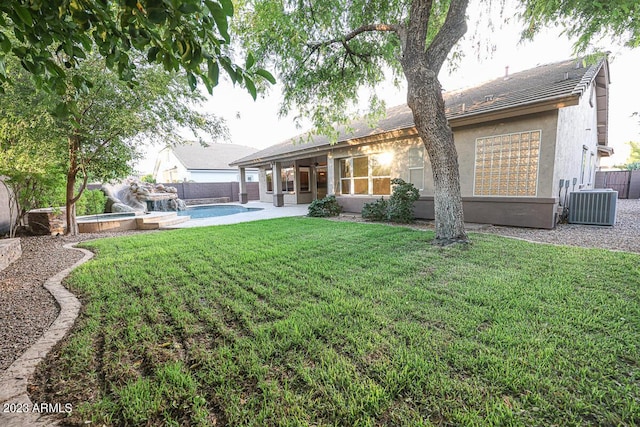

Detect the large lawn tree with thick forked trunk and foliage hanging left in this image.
[242,0,469,244]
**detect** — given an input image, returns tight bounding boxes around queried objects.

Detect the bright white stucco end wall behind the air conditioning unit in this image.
[553,85,599,197]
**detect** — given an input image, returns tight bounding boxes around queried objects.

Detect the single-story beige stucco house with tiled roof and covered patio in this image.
[231,58,613,228]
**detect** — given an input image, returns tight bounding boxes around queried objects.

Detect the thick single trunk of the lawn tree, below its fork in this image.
[407,68,468,245]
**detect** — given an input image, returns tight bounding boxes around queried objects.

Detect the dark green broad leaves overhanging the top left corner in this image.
[0,0,273,99]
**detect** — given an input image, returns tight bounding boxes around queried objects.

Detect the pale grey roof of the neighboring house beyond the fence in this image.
[169,142,258,170]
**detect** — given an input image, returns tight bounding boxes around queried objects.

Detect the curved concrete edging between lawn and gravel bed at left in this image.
[0,243,93,427]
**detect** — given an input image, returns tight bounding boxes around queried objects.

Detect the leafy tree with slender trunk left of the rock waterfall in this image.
[59,57,226,233]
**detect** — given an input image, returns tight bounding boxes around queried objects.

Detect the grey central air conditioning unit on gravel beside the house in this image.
[569,190,618,225]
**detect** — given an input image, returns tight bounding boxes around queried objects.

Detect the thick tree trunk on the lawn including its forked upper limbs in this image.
[399,0,469,245]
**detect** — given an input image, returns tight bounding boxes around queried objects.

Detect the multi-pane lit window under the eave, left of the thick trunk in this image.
[340,153,393,195]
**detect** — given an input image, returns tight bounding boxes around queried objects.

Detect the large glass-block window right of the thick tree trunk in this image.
[473,130,542,197]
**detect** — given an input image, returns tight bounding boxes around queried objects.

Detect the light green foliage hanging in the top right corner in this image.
[522,0,640,51]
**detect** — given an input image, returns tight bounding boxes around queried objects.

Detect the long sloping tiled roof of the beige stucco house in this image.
[231,58,609,166]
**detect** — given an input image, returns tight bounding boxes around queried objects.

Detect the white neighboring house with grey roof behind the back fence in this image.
[153,142,258,182]
